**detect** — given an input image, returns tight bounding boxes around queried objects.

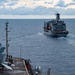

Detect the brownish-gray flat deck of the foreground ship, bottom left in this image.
[0,57,29,75]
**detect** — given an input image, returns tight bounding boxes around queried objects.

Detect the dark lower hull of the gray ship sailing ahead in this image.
[44,30,68,37]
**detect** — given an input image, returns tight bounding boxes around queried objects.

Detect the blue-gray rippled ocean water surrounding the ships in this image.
[0,19,75,75]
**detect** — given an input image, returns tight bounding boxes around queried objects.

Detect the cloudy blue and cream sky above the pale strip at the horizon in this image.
[0,0,75,18]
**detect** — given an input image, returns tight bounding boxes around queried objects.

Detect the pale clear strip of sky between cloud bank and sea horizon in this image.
[0,15,75,19]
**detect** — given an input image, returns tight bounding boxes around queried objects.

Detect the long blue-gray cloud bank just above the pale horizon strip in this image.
[0,6,75,15]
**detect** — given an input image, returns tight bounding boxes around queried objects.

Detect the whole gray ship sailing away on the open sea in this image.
[43,13,69,37]
